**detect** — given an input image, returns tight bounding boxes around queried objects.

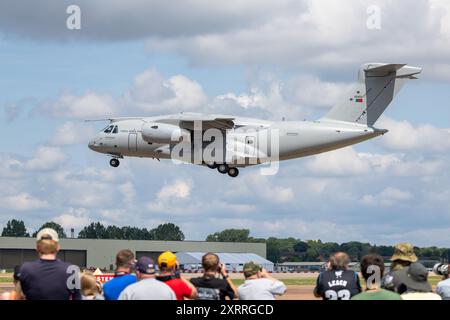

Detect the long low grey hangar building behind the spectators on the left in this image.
[0,237,266,270]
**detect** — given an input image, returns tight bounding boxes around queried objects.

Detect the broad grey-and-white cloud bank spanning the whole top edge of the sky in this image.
[0,0,450,79]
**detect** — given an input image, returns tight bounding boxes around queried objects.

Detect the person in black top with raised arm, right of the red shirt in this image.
[191,253,237,300]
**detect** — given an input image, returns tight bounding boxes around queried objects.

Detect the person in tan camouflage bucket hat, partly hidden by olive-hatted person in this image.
[381,243,417,294]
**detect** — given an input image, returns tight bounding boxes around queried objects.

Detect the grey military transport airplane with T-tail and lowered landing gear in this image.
[87,63,422,178]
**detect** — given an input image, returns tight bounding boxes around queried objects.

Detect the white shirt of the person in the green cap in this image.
[238,279,286,300]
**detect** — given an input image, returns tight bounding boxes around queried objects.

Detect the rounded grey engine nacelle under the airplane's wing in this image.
[142,122,190,144]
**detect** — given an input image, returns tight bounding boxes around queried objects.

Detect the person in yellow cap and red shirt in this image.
[156,251,197,300]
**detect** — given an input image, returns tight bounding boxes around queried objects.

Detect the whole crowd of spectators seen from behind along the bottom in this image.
[0,228,450,300]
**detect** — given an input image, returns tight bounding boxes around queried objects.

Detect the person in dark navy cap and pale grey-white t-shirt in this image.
[119,257,177,300]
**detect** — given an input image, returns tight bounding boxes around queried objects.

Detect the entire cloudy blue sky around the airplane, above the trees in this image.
[0,0,450,247]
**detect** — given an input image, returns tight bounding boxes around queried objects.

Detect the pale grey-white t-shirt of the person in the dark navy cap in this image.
[119,279,177,300]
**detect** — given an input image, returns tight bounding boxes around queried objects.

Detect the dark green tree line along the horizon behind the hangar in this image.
[1,219,450,263]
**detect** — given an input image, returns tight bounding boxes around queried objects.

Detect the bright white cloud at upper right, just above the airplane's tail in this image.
[143,0,450,79]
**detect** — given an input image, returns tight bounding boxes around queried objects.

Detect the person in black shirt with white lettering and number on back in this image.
[314,252,361,300]
